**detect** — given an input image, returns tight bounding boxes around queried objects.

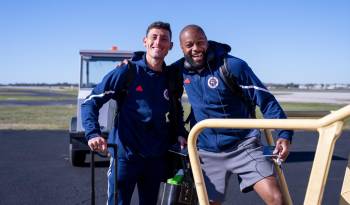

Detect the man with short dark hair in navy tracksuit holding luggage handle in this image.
[81,22,185,205]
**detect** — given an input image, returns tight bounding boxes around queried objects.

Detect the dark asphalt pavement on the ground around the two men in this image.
[0,130,350,205]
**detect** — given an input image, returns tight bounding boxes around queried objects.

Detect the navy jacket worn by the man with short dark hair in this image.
[81,54,183,157]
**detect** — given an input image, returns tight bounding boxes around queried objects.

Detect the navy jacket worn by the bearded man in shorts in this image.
[172,41,293,152]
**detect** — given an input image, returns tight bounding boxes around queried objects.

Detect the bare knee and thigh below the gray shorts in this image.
[253,176,283,205]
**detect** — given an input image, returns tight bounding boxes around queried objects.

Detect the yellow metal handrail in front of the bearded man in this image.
[188,105,350,205]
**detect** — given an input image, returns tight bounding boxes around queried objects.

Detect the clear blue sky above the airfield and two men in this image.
[0,0,350,84]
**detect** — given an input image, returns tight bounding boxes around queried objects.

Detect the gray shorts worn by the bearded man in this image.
[198,137,274,202]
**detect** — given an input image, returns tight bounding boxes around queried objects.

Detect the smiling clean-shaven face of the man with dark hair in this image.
[143,28,172,60]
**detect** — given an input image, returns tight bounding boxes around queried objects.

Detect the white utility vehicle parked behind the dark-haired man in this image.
[69,50,133,166]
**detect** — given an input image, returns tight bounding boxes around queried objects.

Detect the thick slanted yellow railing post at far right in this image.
[304,121,343,205]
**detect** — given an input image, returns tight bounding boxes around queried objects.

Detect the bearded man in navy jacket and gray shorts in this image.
[171,25,293,204]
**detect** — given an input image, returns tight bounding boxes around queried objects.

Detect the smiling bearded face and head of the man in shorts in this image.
[180,27,208,68]
